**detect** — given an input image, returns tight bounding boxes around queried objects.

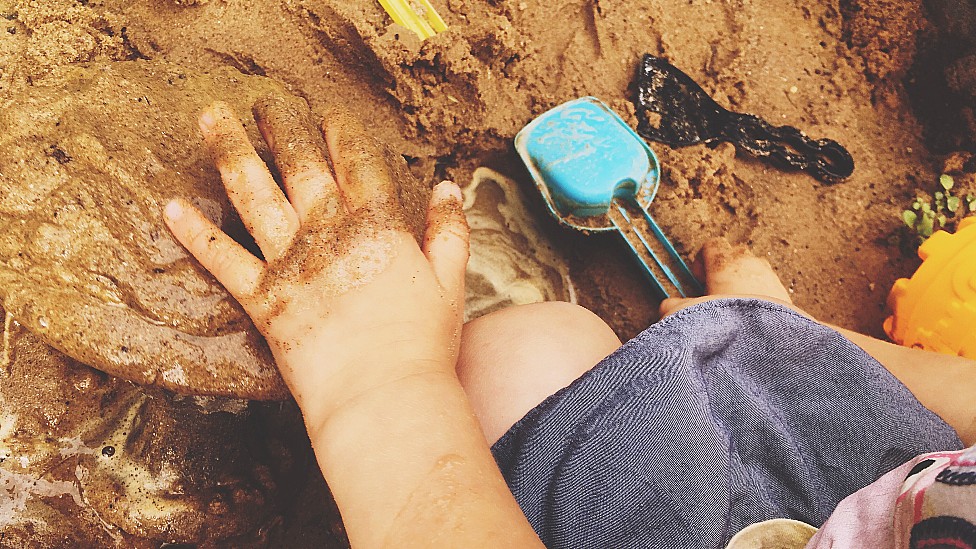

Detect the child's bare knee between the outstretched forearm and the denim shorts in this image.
[457,301,620,443]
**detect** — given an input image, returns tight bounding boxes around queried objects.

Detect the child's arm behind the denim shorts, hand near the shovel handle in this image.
[661,239,976,446]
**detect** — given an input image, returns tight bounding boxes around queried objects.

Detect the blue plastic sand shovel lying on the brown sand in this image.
[515,97,703,297]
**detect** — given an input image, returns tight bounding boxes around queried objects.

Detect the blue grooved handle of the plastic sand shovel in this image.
[607,198,704,299]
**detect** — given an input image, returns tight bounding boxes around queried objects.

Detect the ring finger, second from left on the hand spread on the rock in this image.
[200,102,299,259]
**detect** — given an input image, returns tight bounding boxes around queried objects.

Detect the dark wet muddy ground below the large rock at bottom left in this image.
[0,306,320,548]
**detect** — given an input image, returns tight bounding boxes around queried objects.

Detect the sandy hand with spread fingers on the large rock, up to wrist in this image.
[165,97,468,416]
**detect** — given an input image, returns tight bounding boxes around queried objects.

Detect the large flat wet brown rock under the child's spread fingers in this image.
[0,61,287,399]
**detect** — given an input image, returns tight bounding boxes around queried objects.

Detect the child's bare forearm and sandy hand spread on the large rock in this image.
[166,98,541,547]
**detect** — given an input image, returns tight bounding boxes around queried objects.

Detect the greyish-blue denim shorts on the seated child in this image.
[492,299,963,549]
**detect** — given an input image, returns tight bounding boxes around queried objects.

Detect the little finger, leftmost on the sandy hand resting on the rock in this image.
[164,200,264,301]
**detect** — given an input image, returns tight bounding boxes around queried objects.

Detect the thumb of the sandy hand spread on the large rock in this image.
[423,181,469,300]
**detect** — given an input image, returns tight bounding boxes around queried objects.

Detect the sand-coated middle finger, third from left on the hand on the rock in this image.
[254,95,340,222]
